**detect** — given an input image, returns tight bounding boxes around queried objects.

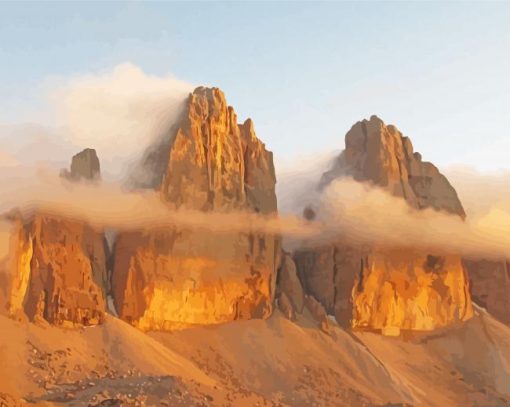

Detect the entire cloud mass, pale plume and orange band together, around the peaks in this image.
[0,64,510,259]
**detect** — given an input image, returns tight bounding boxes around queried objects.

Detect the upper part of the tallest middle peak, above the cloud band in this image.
[160,87,276,212]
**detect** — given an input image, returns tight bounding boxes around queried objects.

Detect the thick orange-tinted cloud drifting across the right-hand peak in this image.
[312,178,510,259]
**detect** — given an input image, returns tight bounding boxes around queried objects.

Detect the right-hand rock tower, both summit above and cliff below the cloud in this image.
[295,116,472,334]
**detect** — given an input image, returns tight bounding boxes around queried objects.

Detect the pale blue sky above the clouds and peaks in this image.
[0,2,510,171]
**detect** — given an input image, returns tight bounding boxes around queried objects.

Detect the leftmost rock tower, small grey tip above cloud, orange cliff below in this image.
[9,150,108,326]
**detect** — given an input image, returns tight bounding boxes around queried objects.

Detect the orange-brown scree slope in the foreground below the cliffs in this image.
[0,311,510,406]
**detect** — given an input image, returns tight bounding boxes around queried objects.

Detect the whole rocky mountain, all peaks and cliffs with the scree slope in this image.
[0,91,510,407]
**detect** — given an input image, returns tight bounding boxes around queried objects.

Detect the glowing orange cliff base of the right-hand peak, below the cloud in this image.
[352,250,473,332]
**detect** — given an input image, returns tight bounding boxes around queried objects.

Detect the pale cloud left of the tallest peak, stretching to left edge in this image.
[0,63,193,178]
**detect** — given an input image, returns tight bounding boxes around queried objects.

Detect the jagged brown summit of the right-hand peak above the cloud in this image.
[321,115,466,218]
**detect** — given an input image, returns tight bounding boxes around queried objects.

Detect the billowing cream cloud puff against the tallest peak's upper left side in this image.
[51,64,193,177]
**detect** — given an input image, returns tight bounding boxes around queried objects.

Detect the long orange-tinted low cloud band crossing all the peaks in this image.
[0,165,510,259]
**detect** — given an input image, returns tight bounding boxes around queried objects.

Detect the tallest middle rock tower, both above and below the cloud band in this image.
[112,87,279,330]
